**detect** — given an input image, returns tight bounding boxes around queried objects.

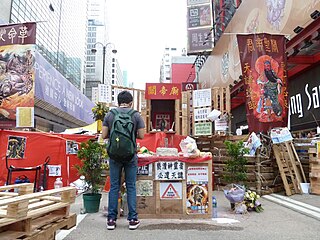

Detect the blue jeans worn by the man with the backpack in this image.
[108,155,138,220]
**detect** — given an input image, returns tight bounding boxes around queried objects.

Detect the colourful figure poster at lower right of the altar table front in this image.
[186,184,209,214]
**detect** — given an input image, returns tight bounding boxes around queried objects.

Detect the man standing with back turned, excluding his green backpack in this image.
[102,91,145,230]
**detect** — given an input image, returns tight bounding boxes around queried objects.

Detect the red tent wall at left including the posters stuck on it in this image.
[0,130,96,189]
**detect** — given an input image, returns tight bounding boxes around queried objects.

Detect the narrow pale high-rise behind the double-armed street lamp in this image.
[85,0,123,100]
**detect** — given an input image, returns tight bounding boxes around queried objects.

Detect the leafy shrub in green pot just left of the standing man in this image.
[75,140,107,213]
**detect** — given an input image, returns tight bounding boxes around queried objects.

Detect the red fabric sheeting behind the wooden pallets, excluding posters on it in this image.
[0,130,95,189]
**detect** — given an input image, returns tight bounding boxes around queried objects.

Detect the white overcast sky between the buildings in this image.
[108,0,187,89]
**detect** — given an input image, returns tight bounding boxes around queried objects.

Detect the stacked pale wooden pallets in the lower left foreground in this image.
[0,183,76,239]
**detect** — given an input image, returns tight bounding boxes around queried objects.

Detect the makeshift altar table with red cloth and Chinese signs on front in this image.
[137,132,212,218]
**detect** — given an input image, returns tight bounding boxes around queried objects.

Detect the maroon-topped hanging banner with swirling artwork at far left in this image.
[0,23,36,128]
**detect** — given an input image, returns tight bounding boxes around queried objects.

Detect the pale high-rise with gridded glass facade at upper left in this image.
[9,0,87,89]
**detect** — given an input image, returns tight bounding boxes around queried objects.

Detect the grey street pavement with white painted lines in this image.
[56,191,320,240]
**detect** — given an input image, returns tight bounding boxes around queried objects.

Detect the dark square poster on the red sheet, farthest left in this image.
[7,136,27,159]
